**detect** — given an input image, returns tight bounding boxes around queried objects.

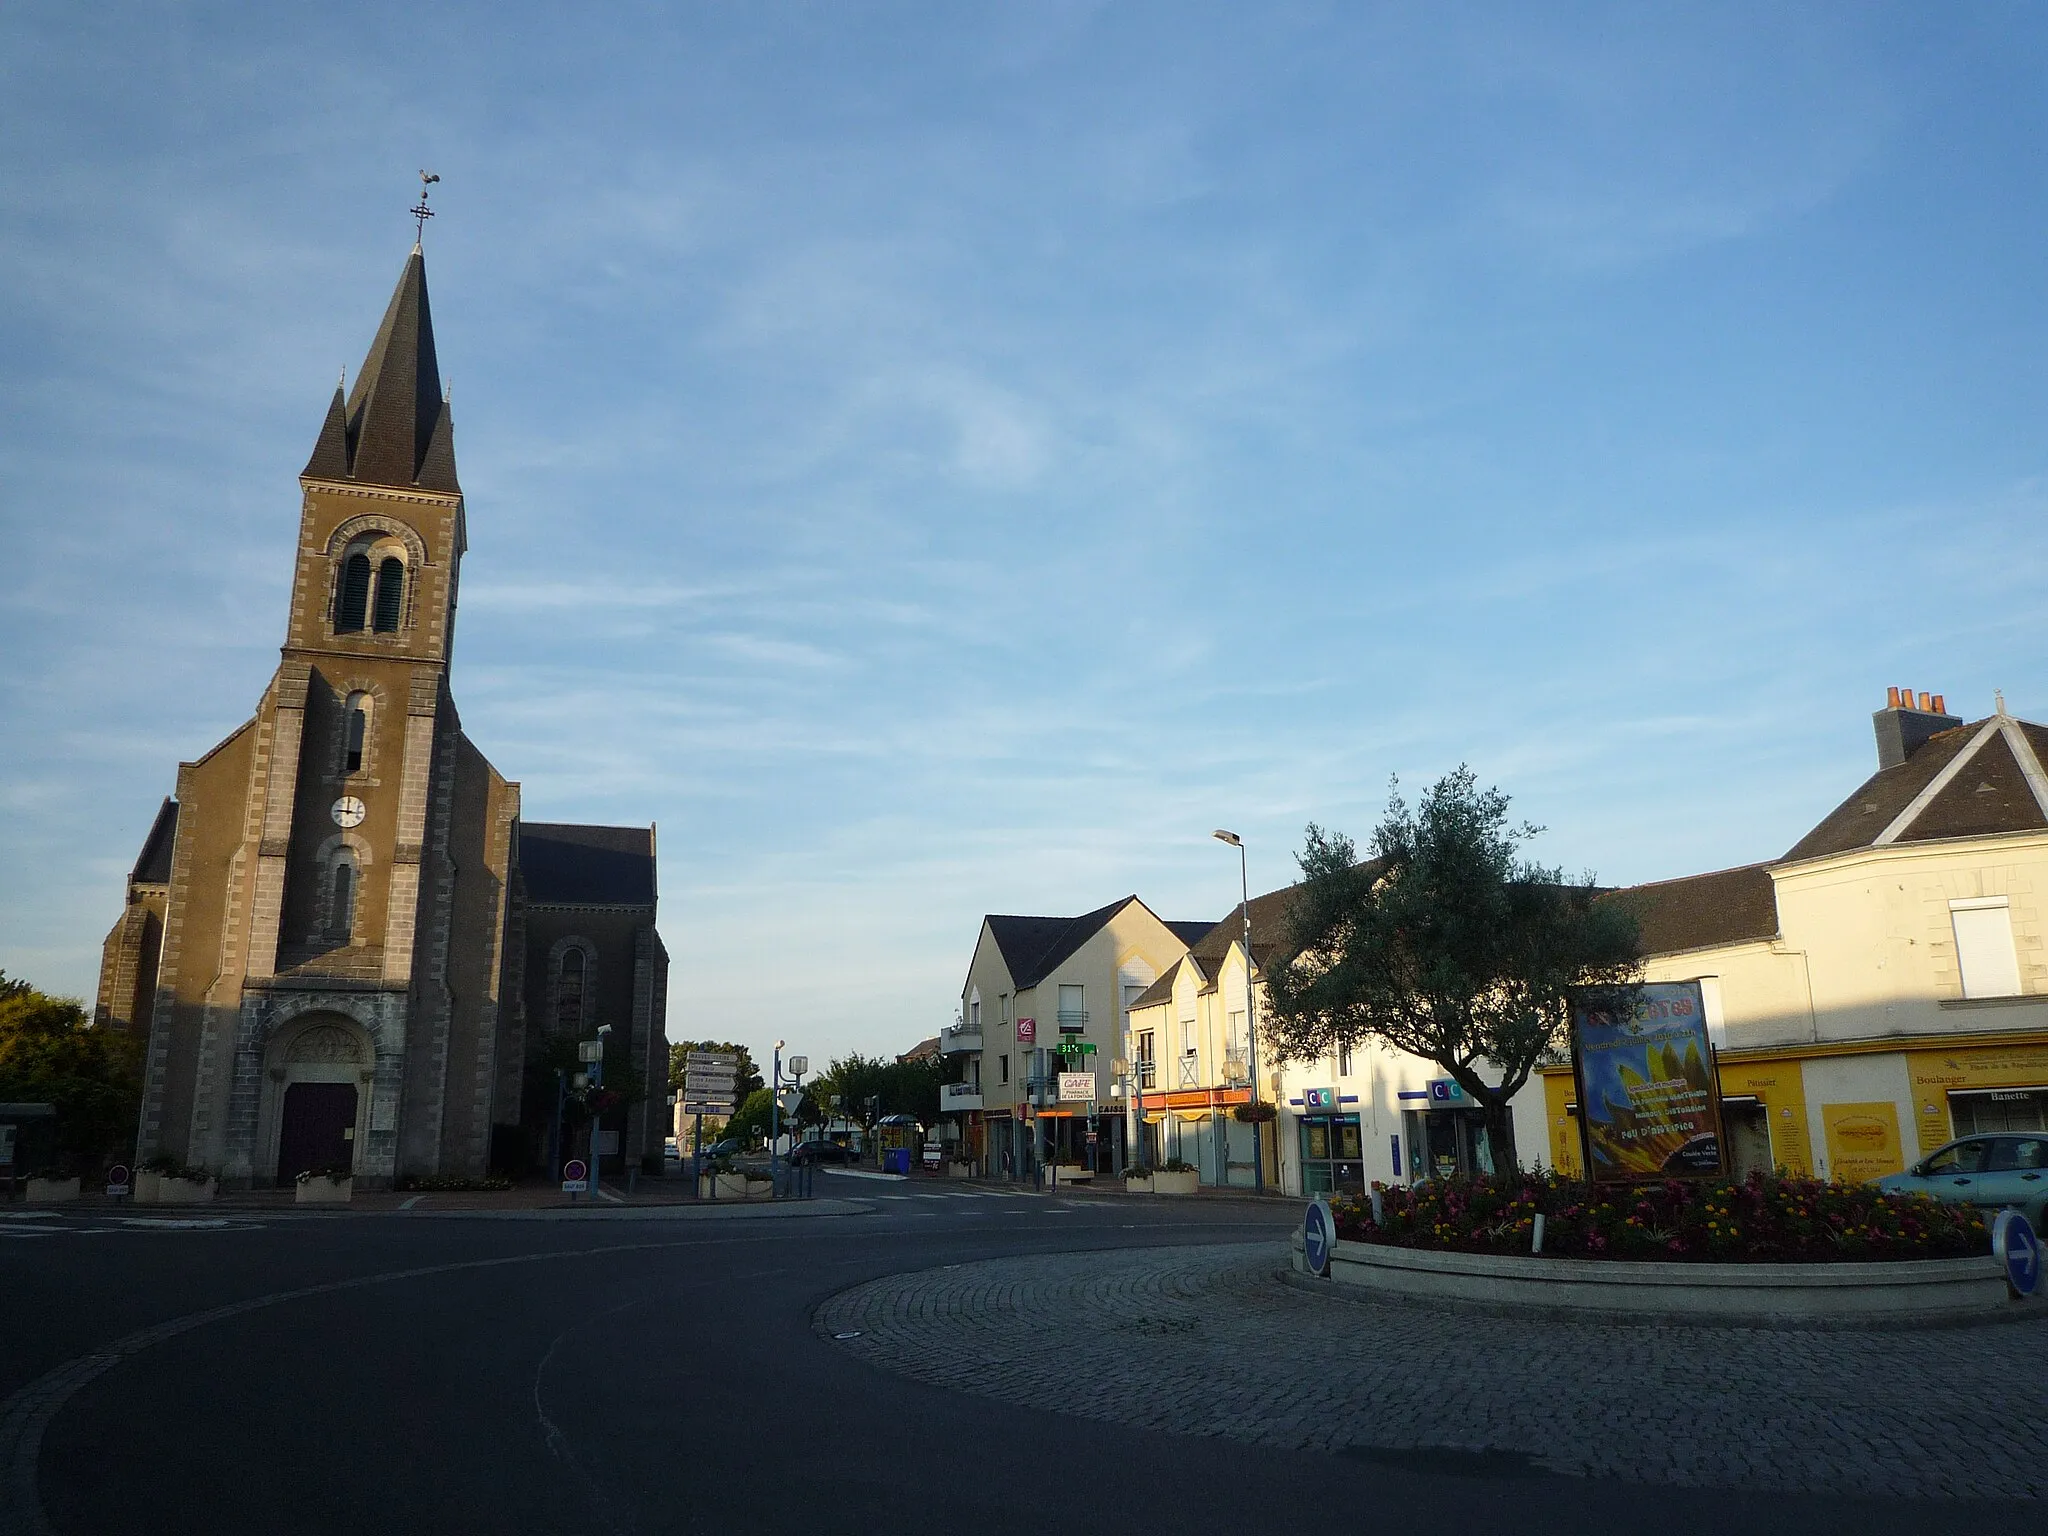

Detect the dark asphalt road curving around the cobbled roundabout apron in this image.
[0,1174,1998,1536]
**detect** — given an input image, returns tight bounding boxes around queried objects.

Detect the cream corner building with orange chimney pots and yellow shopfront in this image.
[1544,688,2048,1178]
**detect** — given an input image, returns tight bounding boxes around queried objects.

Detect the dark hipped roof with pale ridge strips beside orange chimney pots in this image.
[1784,713,2048,862]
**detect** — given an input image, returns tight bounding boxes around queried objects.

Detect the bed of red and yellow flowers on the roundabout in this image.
[1331,1171,1989,1264]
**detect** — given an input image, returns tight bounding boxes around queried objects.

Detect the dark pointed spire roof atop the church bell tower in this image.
[305,246,461,492]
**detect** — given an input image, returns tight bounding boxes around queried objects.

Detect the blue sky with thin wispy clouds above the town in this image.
[0,2,2048,1059]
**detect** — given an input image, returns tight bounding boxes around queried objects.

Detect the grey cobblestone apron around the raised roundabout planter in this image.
[815,1243,2048,1499]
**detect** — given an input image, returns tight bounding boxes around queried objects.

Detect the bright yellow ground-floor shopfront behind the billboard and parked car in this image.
[1542,1032,2048,1180]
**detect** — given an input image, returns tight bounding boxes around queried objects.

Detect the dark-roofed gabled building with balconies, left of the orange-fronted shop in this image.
[940,895,1210,1178]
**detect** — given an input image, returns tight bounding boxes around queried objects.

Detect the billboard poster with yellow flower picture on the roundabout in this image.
[1571,981,1724,1184]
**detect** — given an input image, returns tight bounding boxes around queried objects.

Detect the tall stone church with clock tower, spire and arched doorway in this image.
[96,246,668,1188]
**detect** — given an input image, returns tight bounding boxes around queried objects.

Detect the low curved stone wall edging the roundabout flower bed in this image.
[1292,1231,2023,1327]
